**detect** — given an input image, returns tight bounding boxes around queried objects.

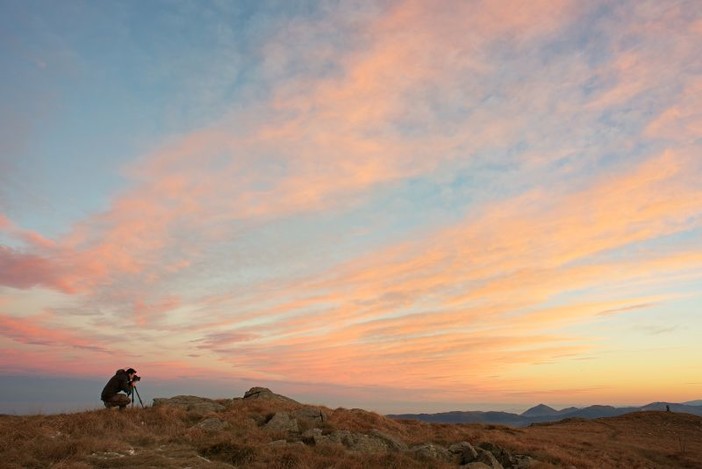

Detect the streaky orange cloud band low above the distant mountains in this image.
[184,147,702,389]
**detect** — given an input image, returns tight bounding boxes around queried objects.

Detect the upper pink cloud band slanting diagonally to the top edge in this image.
[0,1,584,308]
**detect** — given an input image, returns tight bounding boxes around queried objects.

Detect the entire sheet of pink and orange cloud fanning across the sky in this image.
[0,1,702,406]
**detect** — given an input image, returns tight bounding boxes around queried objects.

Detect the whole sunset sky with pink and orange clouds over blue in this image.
[0,0,702,413]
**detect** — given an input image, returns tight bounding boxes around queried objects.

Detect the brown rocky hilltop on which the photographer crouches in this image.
[0,388,702,469]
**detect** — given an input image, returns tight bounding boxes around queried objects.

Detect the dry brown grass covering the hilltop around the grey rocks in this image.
[0,400,702,469]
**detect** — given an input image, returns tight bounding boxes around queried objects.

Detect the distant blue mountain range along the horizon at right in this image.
[387,400,702,427]
